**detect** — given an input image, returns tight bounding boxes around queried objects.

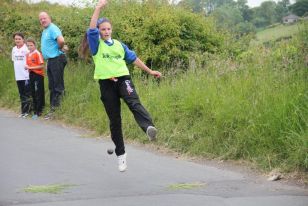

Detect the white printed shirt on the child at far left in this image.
[12,44,29,81]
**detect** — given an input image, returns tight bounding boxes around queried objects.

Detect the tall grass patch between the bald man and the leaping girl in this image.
[59,62,109,134]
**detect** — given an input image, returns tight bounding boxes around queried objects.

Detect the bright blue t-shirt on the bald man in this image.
[41,23,63,59]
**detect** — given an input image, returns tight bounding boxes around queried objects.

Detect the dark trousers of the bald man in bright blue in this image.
[47,54,67,108]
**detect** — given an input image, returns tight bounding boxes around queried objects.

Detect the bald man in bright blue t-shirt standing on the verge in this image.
[39,12,67,119]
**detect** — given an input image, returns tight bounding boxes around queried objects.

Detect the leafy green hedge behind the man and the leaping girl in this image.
[0,0,225,70]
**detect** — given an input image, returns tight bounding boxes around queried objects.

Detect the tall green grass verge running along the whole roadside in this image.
[0,31,308,172]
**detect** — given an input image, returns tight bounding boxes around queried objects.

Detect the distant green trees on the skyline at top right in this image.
[178,0,298,31]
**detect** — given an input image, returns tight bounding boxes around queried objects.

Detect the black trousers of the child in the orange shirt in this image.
[30,72,45,116]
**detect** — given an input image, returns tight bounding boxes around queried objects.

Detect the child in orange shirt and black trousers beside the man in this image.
[25,39,45,119]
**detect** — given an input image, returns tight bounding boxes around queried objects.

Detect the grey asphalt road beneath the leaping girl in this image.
[0,110,308,206]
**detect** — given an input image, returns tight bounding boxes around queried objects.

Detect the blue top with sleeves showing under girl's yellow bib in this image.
[87,28,137,64]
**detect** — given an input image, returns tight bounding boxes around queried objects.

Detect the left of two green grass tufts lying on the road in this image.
[24,184,76,194]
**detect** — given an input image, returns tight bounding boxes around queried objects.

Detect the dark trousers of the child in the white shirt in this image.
[16,80,31,114]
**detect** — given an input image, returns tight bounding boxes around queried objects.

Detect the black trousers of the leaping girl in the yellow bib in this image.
[99,76,153,156]
